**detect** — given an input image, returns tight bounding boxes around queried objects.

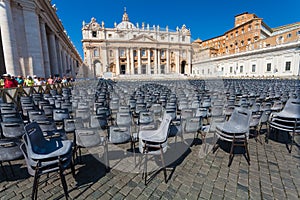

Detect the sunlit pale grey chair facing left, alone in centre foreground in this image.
[138,114,171,185]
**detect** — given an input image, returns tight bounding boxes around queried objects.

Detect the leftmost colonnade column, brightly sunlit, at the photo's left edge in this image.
[0,0,21,75]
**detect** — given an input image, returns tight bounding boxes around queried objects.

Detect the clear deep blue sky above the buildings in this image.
[52,0,300,56]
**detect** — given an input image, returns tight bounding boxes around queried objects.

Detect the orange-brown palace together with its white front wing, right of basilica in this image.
[192,13,300,78]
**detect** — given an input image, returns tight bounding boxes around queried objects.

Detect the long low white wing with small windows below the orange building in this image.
[192,40,300,78]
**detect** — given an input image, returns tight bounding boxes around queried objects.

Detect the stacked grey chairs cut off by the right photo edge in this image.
[266,98,300,153]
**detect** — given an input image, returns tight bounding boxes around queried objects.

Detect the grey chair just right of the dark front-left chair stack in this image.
[74,128,109,170]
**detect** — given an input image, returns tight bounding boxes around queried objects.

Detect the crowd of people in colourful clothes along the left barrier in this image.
[0,74,74,88]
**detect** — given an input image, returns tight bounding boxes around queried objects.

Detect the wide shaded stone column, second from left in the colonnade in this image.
[22,2,45,77]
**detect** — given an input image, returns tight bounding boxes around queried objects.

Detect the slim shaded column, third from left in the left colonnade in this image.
[40,19,51,77]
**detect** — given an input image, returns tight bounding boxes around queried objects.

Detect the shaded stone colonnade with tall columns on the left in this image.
[0,0,82,77]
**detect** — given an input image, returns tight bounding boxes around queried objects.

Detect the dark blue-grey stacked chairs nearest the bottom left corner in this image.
[21,122,75,199]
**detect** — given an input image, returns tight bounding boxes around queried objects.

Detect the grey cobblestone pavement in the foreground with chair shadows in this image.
[0,131,300,199]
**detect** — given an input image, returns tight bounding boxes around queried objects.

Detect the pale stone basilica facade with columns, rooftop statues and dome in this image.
[82,10,192,77]
